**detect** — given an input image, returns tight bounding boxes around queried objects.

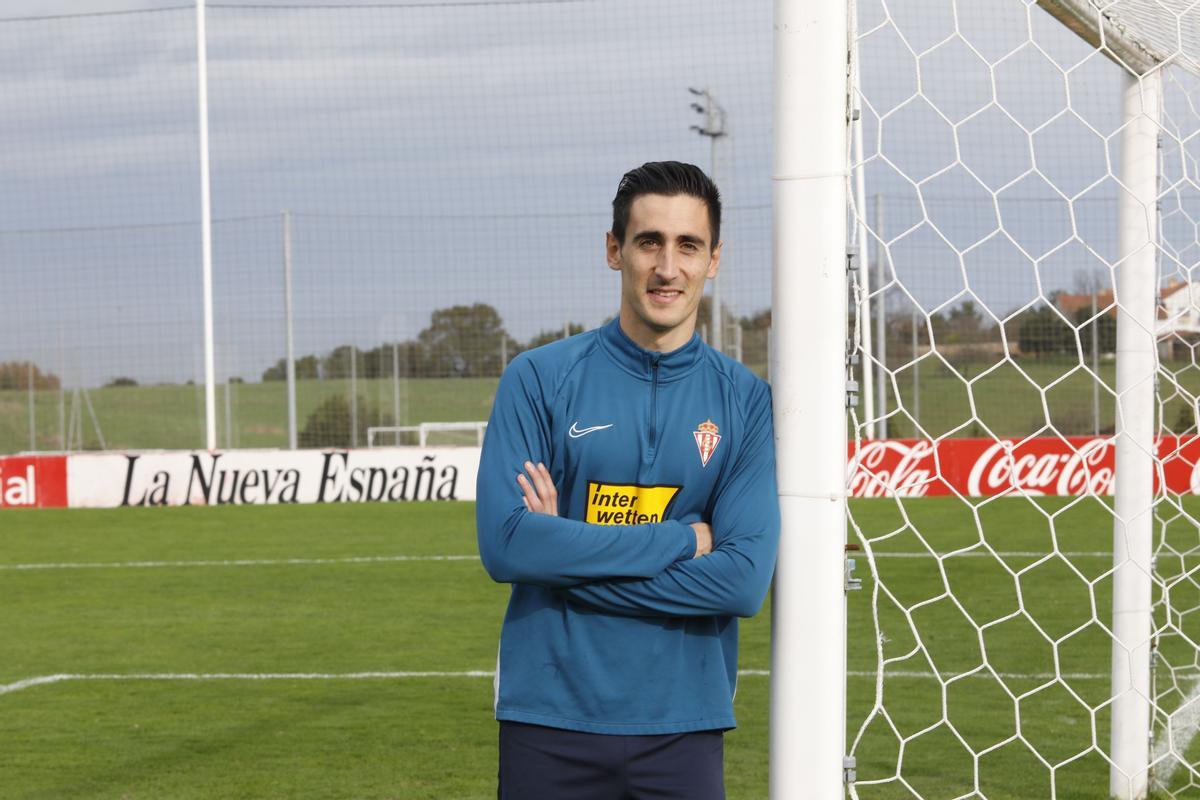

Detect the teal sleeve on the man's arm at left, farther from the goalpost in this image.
[475,354,696,588]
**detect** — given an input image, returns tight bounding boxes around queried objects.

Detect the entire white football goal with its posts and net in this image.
[770,0,1200,798]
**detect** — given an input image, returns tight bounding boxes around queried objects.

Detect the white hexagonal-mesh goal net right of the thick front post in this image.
[847,0,1200,798]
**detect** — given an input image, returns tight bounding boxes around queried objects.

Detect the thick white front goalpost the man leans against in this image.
[770,0,848,800]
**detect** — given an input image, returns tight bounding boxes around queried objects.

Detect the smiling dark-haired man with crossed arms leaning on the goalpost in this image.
[476,162,779,800]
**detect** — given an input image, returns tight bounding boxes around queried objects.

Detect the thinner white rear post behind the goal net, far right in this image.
[1109,71,1162,800]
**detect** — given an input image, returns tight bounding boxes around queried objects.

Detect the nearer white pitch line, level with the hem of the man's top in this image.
[0,669,1109,694]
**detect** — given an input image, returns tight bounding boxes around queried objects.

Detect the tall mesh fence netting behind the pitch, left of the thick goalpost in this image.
[0,0,770,452]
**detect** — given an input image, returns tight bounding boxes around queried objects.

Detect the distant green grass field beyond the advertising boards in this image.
[7,356,1200,453]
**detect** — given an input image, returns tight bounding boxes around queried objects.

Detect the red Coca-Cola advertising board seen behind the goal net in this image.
[848,437,1200,498]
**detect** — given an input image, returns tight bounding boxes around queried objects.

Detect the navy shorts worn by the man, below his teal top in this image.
[497,721,725,800]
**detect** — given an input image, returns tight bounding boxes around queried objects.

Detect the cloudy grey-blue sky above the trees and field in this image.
[0,0,1195,385]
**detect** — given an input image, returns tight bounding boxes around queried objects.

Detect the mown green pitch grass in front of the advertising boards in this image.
[0,499,1200,800]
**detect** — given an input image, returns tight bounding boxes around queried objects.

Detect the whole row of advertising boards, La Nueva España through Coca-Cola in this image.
[7,437,1200,509]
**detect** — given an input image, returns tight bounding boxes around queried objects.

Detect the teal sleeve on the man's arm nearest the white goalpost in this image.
[559,383,779,616]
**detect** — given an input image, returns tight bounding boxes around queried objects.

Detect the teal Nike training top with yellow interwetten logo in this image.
[476,320,779,734]
